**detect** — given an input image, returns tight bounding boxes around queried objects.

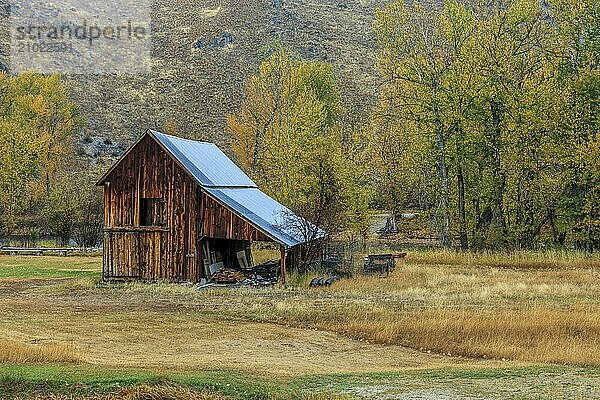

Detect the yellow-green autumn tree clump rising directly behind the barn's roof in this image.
[227,50,368,250]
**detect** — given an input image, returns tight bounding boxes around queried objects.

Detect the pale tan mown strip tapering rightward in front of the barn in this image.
[0,280,508,376]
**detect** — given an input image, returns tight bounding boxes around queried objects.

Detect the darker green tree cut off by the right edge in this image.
[550,0,600,250]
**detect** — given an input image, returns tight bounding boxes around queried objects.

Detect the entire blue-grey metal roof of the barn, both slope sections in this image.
[97,130,325,248]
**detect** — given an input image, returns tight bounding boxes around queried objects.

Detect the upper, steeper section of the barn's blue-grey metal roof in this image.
[152,131,256,187]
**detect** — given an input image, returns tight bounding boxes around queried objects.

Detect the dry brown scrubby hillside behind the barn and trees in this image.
[2,0,384,156]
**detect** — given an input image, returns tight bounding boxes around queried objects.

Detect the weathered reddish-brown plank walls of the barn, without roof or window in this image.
[103,135,278,281]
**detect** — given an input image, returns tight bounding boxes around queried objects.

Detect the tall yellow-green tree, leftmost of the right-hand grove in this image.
[374,3,473,247]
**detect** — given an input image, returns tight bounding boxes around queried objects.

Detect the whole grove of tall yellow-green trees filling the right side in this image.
[374,0,600,248]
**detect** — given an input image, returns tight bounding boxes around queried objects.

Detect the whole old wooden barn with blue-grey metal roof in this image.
[97,130,323,282]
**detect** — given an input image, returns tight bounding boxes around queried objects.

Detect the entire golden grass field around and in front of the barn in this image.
[0,252,600,400]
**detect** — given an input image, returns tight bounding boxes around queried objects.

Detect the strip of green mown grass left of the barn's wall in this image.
[0,255,102,279]
